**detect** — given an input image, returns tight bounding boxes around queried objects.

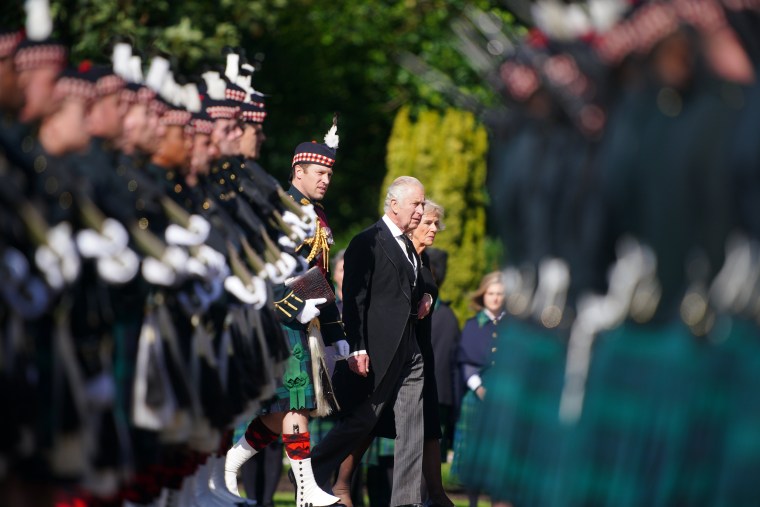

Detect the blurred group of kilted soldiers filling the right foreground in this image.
[460,0,760,506]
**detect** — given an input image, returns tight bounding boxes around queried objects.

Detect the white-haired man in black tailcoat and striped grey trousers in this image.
[312,176,432,506]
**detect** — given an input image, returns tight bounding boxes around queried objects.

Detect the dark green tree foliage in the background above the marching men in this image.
[26,0,514,245]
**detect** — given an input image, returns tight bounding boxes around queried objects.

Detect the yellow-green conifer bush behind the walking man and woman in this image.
[380,107,489,322]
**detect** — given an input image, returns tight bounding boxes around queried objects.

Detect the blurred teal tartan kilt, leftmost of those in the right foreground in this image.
[452,319,566,507]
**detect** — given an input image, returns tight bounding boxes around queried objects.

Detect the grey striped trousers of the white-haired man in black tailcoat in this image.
[311,333,424,506]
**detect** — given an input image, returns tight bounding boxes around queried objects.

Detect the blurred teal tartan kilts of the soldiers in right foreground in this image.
[452,317,760,507]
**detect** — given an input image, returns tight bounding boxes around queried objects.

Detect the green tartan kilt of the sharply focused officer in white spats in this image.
[259,323,317,414]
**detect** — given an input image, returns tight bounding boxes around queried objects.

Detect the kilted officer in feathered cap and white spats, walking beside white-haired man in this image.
[225,122,345,507]
